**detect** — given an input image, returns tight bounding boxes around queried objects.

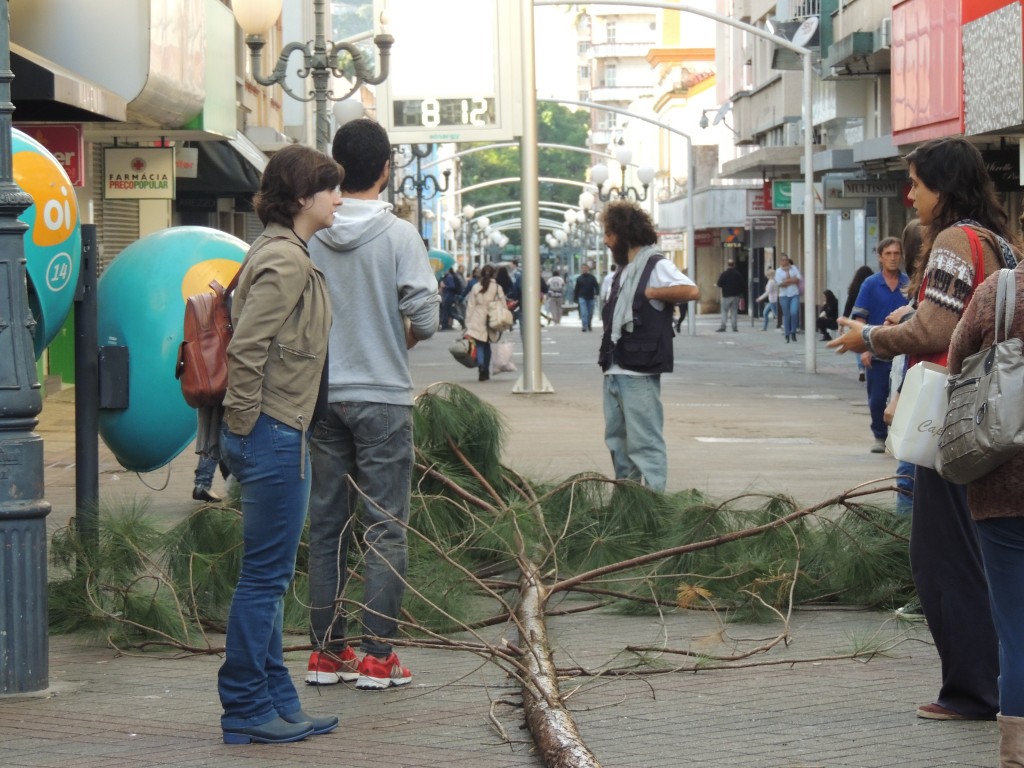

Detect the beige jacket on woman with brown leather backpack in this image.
[224,224,331,435]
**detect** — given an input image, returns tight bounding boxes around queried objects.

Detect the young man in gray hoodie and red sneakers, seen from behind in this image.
[306,119,440,690]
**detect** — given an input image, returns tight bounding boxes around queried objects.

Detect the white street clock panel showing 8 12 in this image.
[374,0,522,144]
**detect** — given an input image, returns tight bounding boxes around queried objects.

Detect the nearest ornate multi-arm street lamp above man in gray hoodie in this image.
[231,0,394,152]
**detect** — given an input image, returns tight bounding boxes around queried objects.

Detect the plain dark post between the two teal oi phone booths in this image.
[75,224,99,565]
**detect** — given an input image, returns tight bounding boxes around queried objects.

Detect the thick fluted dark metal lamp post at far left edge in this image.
[0,0,50,693]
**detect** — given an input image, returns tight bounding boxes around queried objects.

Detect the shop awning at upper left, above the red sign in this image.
[10,43,128,123]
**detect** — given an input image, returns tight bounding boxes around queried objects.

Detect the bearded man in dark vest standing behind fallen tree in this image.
[598,200,700,492]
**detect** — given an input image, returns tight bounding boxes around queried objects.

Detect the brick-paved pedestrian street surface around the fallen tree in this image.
[0,318,997,768]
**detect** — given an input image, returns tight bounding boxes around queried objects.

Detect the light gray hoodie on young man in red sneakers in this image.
[309,198,440,406]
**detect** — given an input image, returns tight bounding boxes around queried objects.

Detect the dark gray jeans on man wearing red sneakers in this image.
[309,402,413,656]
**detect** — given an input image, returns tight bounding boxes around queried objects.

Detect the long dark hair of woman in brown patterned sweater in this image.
[904,136,1014,247]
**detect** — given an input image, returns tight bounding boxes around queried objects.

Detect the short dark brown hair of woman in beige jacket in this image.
[253,144,345,226]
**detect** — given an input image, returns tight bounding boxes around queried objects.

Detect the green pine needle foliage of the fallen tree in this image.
[50,384,912,647]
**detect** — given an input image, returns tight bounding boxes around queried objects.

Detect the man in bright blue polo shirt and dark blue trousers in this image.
[850,238,908,454]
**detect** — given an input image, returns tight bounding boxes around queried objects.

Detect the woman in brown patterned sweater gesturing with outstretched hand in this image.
[828,136,1020,720]
